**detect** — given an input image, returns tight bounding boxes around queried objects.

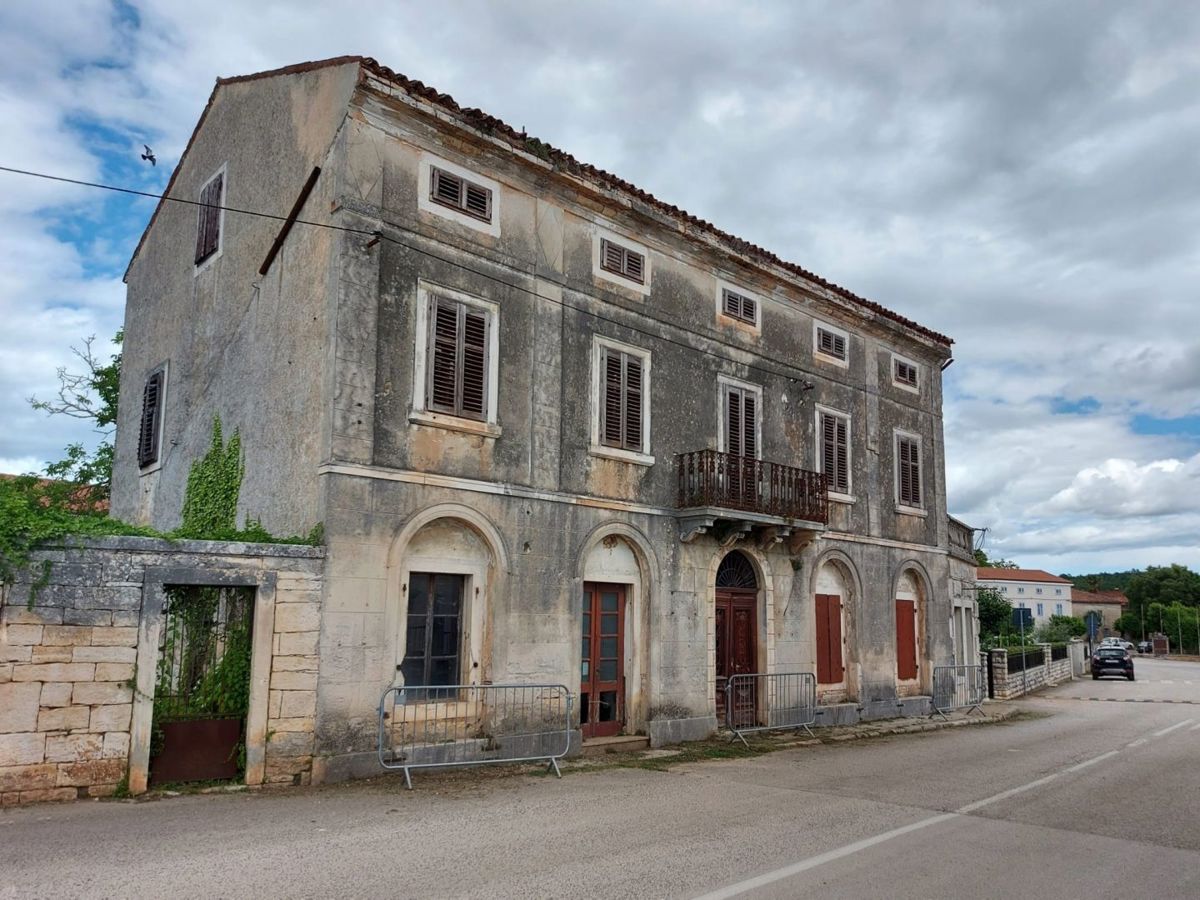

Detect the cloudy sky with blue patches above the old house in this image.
[0,0,1200,572]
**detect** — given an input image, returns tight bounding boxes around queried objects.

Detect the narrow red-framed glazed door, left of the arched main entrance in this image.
[580,582,625,738]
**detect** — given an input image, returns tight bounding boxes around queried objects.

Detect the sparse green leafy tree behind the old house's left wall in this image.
[29,330,125,503]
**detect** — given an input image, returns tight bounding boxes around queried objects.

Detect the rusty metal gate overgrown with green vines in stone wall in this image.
[150,586,254,785]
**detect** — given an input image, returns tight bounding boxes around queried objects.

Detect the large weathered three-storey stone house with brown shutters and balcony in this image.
[113,58,961,779]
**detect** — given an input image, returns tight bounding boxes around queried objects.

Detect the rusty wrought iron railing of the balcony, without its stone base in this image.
[677,450,829,524]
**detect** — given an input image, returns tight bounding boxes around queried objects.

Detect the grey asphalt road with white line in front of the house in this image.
[0,658,1200,900]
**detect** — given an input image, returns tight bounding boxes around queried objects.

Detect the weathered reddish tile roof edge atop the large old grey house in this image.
[126,56,953,347]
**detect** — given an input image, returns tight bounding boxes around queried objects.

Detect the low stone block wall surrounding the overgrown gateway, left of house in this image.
[0,538,324,805]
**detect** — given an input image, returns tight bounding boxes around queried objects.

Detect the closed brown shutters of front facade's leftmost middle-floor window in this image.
[426,298,491,420]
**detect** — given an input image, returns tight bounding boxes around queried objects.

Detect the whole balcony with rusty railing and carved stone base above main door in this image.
[677,450,829,550]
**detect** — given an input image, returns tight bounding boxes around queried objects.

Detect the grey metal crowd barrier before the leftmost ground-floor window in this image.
[379,684,572,790]
